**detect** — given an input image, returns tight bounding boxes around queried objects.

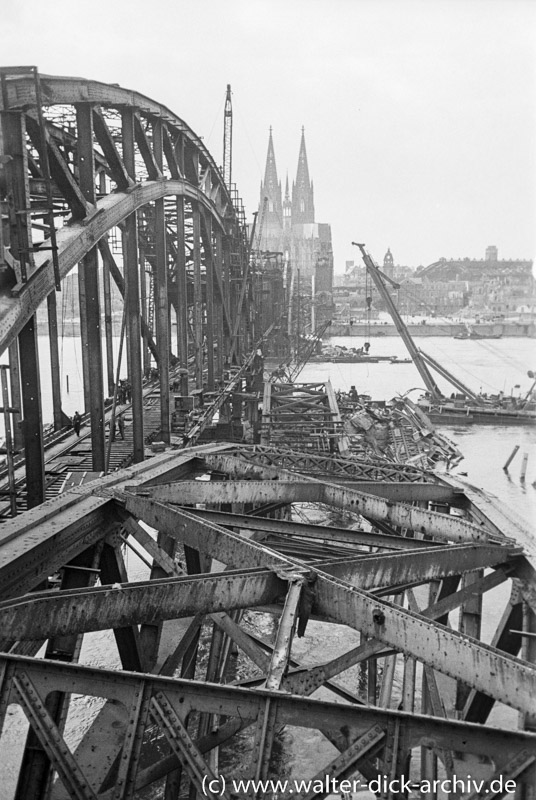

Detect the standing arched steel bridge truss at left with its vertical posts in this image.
[0,72,256,505]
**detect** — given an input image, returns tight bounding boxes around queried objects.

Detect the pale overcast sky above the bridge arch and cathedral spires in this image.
[0,0,536,272]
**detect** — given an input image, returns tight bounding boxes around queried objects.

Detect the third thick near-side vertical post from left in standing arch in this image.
[121,108,145,464]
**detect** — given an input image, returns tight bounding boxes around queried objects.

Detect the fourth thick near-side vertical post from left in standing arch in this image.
[153,120,171,444]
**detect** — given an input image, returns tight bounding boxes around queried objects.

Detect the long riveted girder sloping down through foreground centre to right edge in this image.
[126,495,536,710]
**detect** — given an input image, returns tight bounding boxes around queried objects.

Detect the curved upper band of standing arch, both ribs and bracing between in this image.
[0,68,243,353]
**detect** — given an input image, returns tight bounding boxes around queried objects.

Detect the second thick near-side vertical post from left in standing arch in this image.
[76,103,106,472]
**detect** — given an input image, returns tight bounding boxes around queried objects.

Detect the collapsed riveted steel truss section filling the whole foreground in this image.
[0,443,536,800]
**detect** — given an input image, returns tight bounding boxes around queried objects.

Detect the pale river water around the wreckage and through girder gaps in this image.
[0,337,536,797]
